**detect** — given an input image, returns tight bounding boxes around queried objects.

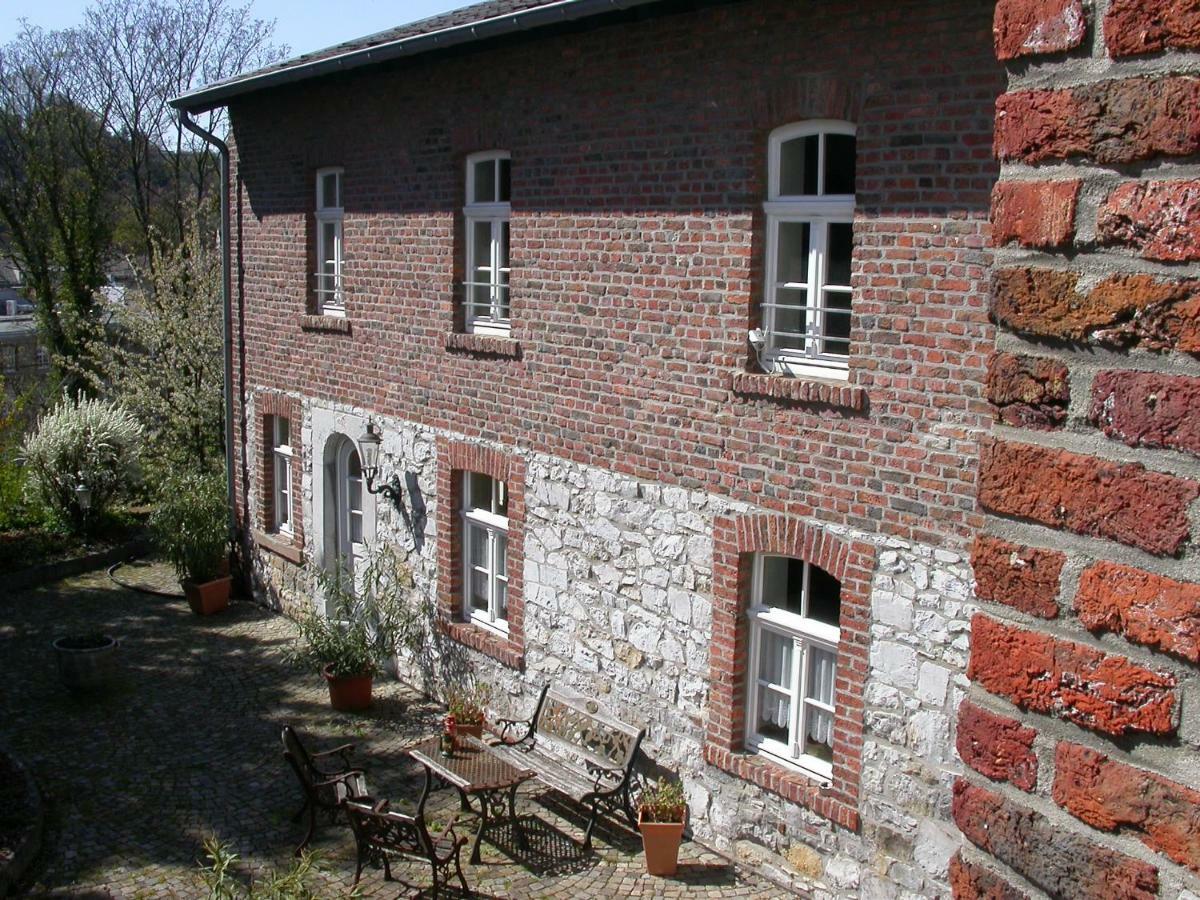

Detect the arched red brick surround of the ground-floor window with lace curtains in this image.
[704,514,875,830]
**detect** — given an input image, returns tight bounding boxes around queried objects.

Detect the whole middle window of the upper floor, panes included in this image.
[462,150,512,335]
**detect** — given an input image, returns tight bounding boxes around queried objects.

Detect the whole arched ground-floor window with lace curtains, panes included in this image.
[746,553,841,780]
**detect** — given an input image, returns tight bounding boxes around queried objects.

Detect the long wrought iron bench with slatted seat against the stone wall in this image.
[493,685,646,850]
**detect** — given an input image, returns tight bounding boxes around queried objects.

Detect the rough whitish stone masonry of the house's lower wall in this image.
[241,398,974,899]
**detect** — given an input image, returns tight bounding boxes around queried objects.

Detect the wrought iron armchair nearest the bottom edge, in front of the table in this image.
[346,794,470,896]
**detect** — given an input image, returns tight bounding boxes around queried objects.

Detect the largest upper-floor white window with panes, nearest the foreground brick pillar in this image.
[762,120,856,378]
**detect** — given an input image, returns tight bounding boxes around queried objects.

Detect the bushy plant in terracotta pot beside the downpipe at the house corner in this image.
[150,472,232,616]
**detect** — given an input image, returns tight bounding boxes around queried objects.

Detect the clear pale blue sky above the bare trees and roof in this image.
[0,0,473,55]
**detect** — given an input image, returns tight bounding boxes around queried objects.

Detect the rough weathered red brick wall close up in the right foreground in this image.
[950,0,1200,899]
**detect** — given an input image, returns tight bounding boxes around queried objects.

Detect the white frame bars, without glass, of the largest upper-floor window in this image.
[762,119,858,380]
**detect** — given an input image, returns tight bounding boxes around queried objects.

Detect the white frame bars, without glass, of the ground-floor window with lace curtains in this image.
[746,553,841,781]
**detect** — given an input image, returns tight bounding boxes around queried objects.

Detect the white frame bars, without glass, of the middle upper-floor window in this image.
[462,150,512,336]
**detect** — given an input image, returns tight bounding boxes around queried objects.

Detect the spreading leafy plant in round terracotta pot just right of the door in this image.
[292,548,427,712]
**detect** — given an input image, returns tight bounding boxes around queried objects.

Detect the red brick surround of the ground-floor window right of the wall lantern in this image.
[437,438,524,670]
